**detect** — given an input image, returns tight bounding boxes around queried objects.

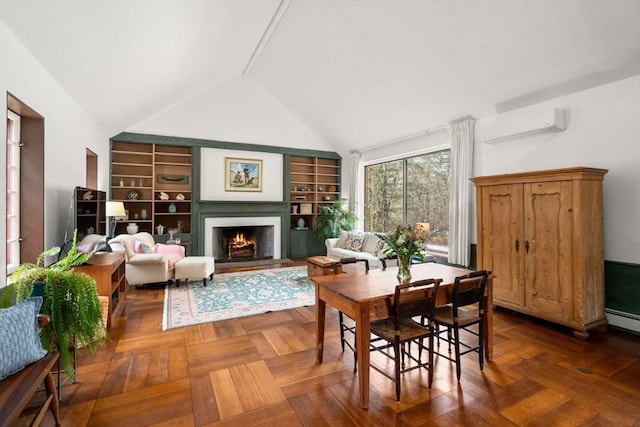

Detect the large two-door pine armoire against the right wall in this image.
[472,167,607,338]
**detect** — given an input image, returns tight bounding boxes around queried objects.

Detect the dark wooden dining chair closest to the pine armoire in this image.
[433,270,491,381]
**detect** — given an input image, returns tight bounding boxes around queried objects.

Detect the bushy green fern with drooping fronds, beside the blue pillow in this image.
[0,232,105,379]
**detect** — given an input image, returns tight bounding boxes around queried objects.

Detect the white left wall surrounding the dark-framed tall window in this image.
[0,21,109,282]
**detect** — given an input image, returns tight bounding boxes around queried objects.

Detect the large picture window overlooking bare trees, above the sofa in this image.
[364,149,451,252]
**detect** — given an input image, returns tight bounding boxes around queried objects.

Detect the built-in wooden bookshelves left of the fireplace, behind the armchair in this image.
[111,142,192,240]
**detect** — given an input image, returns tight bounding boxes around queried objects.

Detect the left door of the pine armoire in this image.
[478,184,524,305]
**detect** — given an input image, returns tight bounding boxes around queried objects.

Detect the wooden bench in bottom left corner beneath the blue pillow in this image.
[0,316,60,427]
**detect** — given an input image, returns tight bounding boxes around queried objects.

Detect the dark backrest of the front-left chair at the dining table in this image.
[392,279,442,329]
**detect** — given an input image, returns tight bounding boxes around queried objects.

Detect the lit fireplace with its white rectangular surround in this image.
[204,216,282,263]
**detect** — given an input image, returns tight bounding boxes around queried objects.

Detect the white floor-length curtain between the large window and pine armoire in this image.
[449,118,475,266]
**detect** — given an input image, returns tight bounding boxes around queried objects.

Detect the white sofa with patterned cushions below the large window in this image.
[325,231,385,270]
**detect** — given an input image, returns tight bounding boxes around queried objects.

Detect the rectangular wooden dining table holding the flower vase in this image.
[311,262,493,409]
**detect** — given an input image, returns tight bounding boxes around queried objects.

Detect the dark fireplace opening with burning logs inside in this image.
[213,225,274,262]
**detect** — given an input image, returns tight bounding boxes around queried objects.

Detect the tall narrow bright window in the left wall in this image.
[6,110,20,274]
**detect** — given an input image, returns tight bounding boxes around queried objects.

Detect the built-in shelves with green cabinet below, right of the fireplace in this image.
[288,156,340,257]
